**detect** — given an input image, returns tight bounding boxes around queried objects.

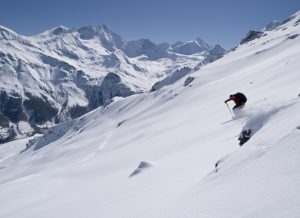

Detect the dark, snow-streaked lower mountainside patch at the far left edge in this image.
[0,91,58,140]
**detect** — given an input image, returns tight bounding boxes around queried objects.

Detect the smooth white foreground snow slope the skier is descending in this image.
[0,12,300,218]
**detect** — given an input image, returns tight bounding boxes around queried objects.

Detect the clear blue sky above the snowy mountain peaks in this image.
[0,0,300,49]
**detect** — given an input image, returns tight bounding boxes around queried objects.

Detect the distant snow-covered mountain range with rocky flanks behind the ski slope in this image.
[0,25,225,143]
